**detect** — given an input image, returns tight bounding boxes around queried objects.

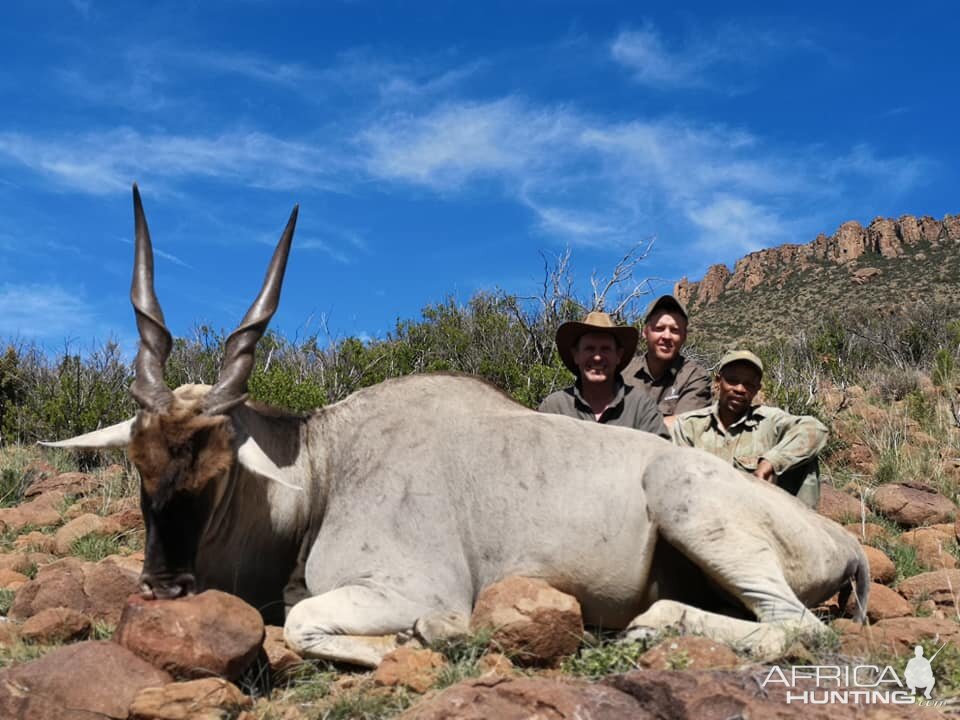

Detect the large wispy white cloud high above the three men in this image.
[350,98,925,257]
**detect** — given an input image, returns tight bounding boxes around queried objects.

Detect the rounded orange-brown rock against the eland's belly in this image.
[470,577,583,664]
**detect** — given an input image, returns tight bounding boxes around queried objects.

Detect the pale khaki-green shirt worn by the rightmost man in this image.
[671,404,827,476]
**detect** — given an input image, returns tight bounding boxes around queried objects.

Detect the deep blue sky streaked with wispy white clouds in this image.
[0,0,960,351]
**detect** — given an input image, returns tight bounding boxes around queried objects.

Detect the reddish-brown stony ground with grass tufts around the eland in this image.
[0,380,960,720]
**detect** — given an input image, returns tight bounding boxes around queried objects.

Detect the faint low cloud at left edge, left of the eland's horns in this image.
[0,284,95,339]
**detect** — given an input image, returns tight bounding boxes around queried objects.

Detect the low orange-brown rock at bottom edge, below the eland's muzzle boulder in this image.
[129,678,253,720]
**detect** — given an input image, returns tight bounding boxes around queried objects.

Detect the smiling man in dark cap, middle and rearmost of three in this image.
[623,295,711,428]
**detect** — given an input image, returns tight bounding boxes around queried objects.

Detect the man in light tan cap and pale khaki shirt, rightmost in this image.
[671,350,827,508]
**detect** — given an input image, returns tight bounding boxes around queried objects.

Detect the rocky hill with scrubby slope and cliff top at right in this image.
[674,215,960,344]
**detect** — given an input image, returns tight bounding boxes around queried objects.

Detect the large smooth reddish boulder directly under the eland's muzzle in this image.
[114,590,265,680]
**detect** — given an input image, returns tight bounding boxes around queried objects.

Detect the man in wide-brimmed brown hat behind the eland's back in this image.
[540,312,670,439]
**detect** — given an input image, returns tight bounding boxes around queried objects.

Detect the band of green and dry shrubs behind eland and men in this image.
[0,286,960,443]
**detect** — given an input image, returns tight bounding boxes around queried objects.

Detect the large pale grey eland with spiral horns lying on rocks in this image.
[50,186,869,666]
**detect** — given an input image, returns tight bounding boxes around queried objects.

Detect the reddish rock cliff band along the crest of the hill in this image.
[674,215,960,310]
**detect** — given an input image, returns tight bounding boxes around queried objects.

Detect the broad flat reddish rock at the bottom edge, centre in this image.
[398,675,655,720]
